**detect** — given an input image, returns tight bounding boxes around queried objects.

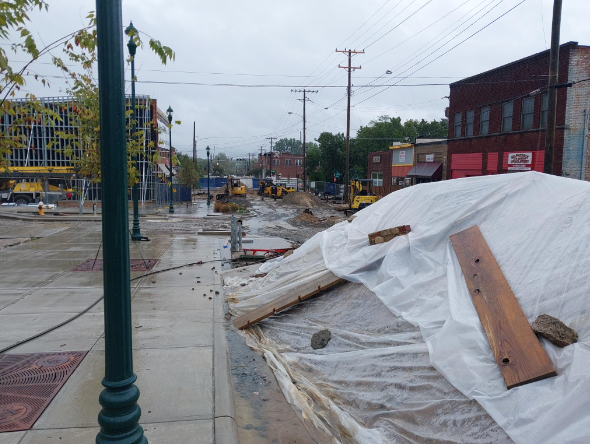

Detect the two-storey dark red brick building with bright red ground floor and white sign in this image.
[446,42,590,179]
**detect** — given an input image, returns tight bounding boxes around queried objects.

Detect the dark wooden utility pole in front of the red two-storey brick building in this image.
[543,0,562,174]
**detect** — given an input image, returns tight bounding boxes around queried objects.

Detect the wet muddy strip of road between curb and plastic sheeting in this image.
[226,322,316,444]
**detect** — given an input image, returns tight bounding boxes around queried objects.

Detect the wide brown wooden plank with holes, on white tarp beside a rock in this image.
[451,225,556,389]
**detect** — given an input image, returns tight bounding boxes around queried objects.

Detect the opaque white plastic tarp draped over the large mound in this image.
[232,172,590,444]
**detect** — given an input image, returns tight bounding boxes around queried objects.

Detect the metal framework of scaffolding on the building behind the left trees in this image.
[0,95,160,202]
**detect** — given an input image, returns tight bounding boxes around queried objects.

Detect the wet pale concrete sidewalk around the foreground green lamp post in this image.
[0,227,237,444]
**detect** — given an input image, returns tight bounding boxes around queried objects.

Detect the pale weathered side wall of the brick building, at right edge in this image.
[563,47,590,180]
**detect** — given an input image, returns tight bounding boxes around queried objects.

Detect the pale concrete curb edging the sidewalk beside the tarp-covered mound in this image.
[213,240,239,444]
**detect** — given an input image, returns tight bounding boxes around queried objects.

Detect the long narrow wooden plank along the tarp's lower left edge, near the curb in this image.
[232,273,344,330]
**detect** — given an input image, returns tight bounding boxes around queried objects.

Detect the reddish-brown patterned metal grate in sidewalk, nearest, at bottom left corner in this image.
[0,352,87,433]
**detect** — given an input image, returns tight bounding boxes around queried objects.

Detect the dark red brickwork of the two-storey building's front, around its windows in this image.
[446,42,581,178]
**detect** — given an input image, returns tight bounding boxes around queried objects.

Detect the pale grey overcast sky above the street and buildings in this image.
[9,0,590,157]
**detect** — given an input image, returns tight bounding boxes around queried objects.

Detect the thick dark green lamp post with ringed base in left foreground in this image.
[96,0,147,444]
